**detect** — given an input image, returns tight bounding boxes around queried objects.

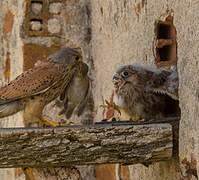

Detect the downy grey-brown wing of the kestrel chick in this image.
[147,70,179,100]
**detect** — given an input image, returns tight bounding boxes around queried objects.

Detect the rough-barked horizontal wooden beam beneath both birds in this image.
[0,121,173,168]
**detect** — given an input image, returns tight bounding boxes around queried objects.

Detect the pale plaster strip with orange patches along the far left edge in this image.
[0,0,25,180]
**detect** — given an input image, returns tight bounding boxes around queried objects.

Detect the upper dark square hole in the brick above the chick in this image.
[157,24,171,39]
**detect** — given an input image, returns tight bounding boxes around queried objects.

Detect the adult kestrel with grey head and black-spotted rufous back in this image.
[0,48,85,126]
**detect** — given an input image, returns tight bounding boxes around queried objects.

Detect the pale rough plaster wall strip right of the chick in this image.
[175,1,199,179]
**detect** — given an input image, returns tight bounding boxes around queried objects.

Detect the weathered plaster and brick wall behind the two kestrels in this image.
[0,0,199,180]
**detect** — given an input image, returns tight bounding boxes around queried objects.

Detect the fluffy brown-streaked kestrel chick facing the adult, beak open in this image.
[113,64,180,120]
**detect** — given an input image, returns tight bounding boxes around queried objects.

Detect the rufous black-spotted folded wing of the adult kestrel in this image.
[0,62,68,104]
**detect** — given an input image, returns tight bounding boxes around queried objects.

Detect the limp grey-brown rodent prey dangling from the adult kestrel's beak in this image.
[60,64,91,119]
